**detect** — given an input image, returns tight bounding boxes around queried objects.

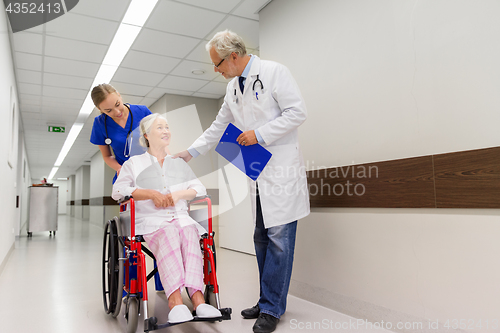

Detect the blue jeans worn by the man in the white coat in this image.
[253,190,297,318]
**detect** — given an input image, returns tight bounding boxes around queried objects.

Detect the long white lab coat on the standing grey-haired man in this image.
[190,57,310,228]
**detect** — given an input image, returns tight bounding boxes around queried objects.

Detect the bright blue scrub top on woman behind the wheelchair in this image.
[90,104,151,184]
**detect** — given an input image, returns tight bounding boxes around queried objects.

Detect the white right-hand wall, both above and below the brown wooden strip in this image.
[260,0,500,332]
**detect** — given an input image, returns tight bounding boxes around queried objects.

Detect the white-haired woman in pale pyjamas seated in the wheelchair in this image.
[112,113,221,323]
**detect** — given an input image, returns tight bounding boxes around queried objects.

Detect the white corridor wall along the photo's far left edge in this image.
[0,3,21,271]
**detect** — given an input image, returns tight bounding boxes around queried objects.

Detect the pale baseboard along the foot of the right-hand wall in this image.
[289,279,467,333]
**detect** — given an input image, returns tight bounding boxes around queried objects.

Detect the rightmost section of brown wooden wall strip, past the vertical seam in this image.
[434,147,500,208]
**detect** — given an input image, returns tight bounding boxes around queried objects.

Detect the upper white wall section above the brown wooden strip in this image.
[260,0,500,166]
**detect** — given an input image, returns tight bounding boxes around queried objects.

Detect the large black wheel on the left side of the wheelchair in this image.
[102,220,123,317]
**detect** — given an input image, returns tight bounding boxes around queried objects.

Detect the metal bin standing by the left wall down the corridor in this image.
[26,186,59,237]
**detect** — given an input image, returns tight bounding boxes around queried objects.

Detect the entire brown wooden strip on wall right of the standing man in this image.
[307,147,500,208]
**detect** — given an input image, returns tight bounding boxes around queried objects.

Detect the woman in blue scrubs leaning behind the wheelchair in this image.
[90,83,151,184]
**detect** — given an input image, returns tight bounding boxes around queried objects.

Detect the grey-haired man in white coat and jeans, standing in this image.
[176,30,310,333]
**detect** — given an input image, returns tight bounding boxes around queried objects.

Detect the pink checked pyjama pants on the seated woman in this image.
[143,219,203,297]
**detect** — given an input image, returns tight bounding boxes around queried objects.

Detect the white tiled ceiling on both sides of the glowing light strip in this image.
[11,0,270,179]
